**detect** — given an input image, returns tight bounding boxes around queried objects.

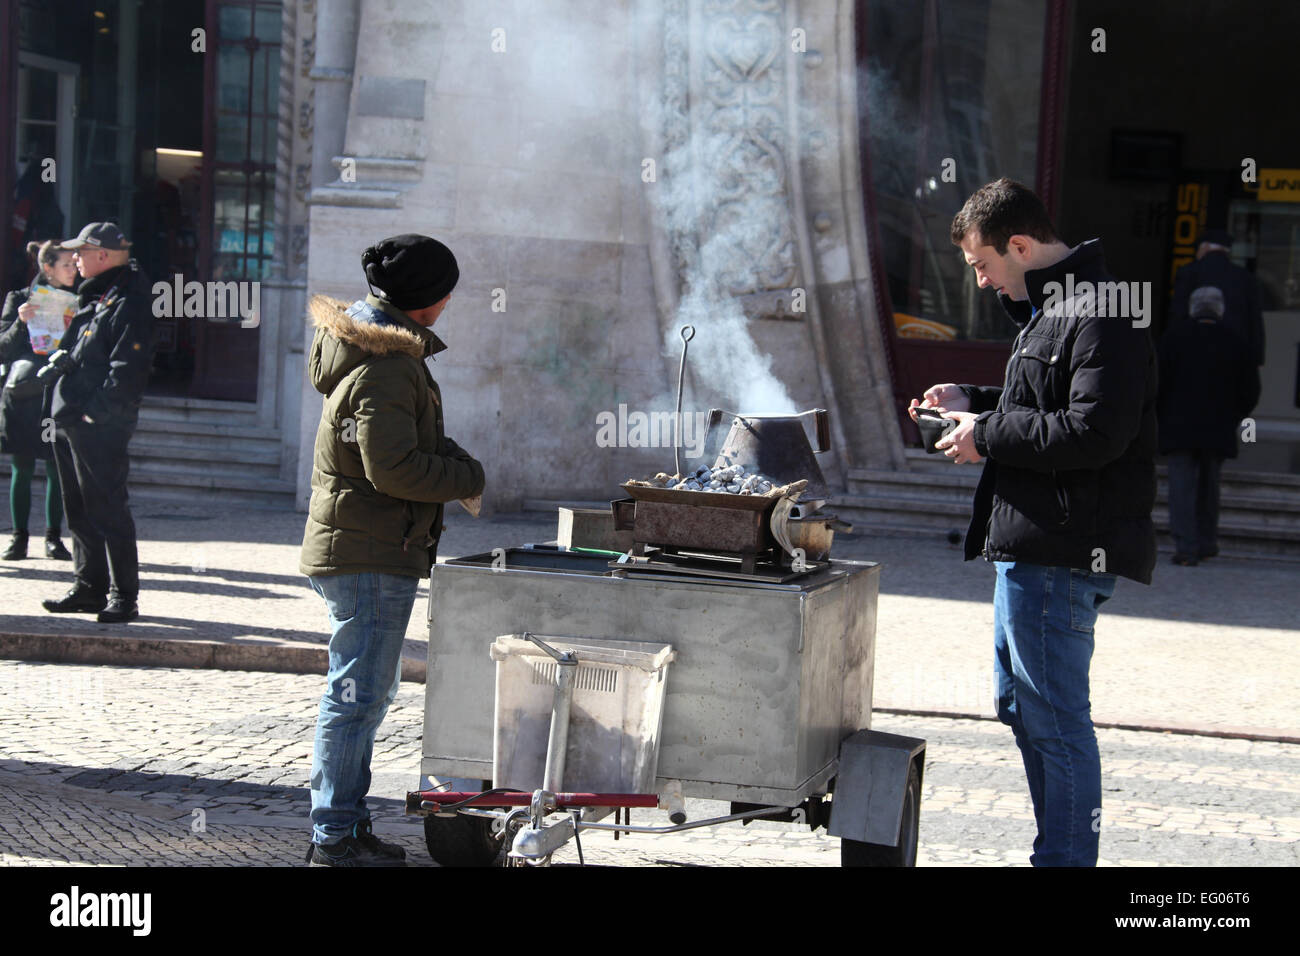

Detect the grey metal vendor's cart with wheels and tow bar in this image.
[407,546,926,865]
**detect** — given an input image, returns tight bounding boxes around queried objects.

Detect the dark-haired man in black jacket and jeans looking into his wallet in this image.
[913,178,1156,866]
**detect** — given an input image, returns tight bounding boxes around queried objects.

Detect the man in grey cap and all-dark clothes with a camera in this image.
[40,222,153,624]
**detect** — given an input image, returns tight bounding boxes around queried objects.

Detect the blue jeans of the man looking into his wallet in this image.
[993,561,1115,866]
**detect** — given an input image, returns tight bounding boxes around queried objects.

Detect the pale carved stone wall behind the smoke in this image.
[298,0,901,510]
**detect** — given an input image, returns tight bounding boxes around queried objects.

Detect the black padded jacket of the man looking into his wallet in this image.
[962,239,1156,584]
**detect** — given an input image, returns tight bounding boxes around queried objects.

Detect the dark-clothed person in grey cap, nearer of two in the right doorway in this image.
[1156,286,1260,566]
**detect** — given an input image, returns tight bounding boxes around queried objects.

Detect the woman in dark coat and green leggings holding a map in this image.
[0,239,77,561]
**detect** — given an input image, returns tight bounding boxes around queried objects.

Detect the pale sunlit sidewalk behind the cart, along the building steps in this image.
[0,504,1300,739]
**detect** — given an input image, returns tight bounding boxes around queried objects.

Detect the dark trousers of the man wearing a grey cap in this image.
[55,424,140,601]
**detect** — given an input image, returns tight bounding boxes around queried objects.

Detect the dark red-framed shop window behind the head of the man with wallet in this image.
[858,0,1047,342]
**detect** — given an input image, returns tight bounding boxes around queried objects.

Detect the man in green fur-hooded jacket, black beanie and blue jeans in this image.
[300,234,484,866]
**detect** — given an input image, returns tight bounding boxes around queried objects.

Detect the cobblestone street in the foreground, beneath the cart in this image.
[0,661,1300,866]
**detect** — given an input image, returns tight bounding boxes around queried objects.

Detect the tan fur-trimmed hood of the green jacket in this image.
[308,295,447,395]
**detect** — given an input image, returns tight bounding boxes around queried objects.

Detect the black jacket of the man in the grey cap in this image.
[51,259,153,432]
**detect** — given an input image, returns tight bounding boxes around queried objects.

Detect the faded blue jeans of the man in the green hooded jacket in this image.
[308,574,420,844]
